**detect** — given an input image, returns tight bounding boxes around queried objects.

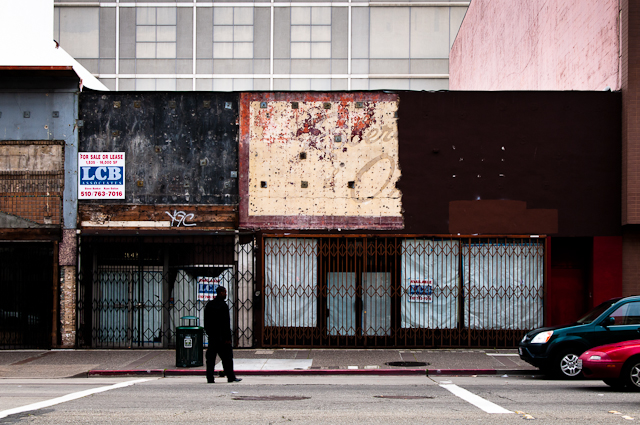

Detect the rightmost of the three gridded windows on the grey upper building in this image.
[291,7,331,59]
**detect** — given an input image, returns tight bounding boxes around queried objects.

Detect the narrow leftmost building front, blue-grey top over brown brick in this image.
[0,67,80,348]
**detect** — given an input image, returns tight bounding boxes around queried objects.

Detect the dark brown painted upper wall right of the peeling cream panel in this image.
[398,92,621,236]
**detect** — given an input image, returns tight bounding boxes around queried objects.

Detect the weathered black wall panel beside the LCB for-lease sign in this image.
[80,92,238,205]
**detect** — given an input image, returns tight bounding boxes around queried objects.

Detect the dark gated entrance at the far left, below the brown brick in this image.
[0,242,54,349]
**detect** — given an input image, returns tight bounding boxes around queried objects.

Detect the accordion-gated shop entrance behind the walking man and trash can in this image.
[77,233,254,348]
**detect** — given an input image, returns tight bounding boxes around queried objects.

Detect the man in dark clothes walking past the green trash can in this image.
[204,286,242,384]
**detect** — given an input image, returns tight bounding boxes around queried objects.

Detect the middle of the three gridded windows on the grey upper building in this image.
[213,7,254,59]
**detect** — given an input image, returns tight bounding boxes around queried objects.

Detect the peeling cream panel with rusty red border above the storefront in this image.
[240,92,403,229]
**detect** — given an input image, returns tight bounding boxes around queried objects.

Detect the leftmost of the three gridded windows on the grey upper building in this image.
[136,7,177,59]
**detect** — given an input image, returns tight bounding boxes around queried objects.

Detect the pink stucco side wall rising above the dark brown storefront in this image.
[449,0,621,90]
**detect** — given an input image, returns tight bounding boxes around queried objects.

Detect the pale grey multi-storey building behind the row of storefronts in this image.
[53,0,469,91]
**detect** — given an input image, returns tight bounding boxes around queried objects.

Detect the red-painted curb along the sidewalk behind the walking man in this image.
[87,369,541,378]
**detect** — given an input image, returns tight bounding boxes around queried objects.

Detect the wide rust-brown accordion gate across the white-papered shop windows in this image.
[261,235,545,347]
